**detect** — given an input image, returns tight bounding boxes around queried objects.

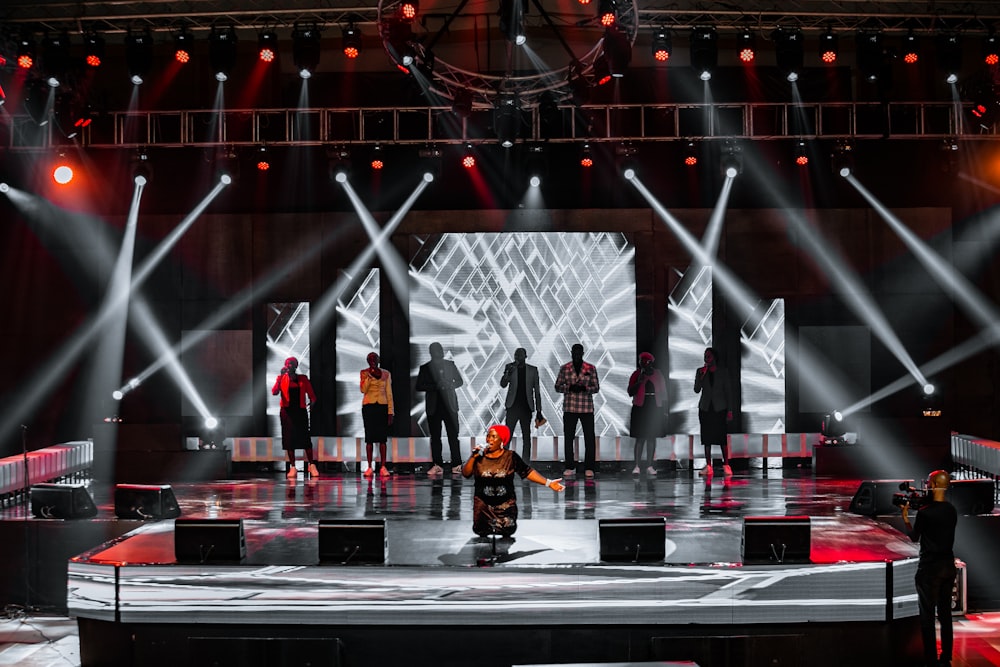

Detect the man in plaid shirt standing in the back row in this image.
[556,343,601,479]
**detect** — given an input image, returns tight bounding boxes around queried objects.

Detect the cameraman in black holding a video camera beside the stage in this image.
[901,470,958,667]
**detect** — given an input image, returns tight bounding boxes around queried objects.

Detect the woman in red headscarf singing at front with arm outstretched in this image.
[462,424,565,537]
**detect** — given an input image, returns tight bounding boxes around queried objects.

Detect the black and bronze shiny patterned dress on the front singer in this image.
[472,449,531,537]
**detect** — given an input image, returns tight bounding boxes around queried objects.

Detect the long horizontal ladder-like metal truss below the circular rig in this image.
[0,102,1000,151]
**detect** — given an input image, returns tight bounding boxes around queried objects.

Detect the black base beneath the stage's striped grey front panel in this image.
[79,617,920,667]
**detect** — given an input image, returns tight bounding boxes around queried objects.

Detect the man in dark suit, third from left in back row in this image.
[416,343,463,477]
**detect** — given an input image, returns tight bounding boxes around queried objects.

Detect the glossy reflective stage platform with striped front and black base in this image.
[4,468,952,666]
